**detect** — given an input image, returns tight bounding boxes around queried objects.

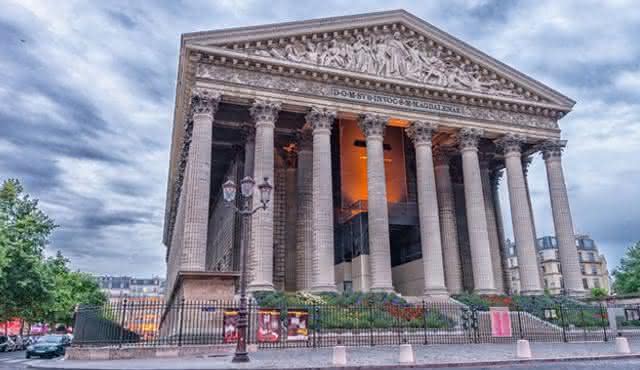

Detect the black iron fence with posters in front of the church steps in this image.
[73,300,624,348]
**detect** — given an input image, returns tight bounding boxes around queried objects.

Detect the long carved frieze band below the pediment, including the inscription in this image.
[196,63,558,129]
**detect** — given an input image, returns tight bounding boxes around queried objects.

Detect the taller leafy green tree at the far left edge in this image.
[0,179,56,321]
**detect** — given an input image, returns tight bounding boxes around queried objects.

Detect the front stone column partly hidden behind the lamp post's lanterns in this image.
[249,100,280,292]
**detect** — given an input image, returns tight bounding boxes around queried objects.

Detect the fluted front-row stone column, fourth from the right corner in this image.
[407,121,449,298]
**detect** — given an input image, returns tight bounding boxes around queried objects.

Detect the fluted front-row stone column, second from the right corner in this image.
[497,134,542,295]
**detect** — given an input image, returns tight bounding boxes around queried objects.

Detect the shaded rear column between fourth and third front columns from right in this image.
[434,146,462,294]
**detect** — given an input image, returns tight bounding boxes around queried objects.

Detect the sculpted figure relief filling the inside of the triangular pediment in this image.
[247,32,531,99]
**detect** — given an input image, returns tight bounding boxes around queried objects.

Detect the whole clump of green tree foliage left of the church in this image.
[0,179,105,324]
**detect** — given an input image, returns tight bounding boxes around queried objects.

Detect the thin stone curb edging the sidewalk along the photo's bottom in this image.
[27,354,640,370]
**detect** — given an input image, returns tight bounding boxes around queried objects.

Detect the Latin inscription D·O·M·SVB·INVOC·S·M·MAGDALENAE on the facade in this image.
[331,87,464,115]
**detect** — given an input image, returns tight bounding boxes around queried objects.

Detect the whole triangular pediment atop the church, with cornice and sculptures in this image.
[185,10,574,110]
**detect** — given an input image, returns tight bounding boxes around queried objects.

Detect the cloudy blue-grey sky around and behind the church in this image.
[0,0,640,276]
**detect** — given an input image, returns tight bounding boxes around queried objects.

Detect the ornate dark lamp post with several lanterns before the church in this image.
[222,176,273,362]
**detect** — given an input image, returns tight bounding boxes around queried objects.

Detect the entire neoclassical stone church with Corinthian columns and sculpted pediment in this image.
[164,10,584,308]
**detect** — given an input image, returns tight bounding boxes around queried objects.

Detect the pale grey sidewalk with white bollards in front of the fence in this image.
[31,342,640,370]
